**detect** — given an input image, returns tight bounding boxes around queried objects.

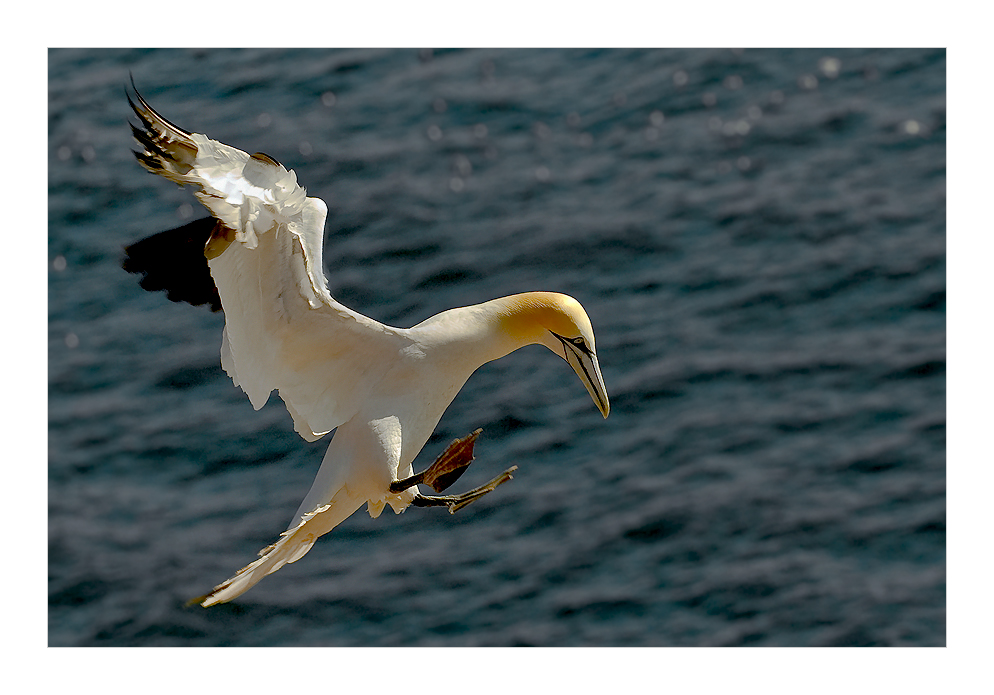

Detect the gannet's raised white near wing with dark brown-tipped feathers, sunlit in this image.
[128,85,406,441]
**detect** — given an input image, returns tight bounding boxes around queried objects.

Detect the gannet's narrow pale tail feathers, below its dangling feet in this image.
[190,486,366,608]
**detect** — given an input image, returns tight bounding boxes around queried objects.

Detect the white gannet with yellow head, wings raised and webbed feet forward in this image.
[124,81,610,607]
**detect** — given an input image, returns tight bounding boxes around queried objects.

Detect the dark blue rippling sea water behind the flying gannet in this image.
[48,50,946,646]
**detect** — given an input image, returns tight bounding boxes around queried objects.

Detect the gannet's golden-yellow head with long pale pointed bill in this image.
[494,292,611,417]
